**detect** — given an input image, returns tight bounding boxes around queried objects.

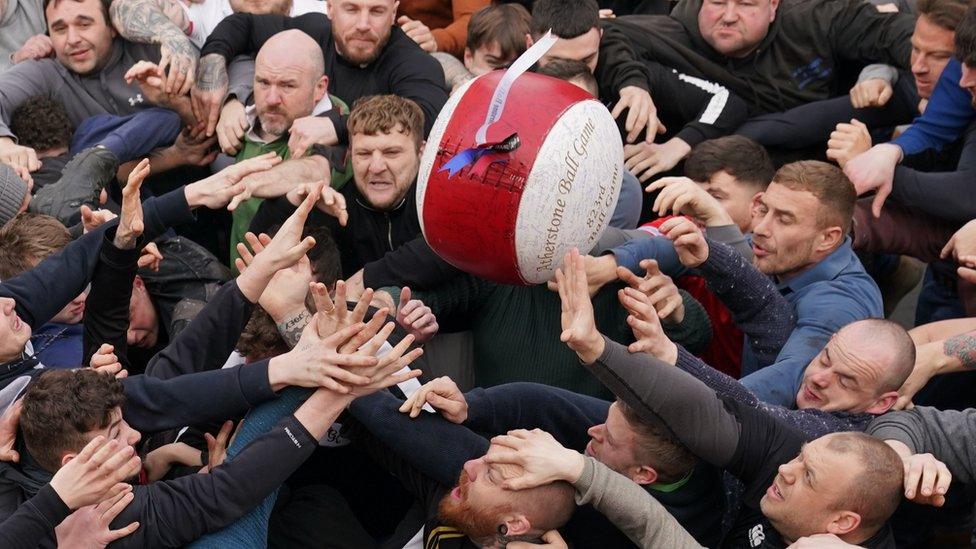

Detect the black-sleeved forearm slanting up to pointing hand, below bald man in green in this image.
[146,281,253,379]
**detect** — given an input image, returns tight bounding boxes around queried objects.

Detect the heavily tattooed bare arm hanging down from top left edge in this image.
[109,0,200,94]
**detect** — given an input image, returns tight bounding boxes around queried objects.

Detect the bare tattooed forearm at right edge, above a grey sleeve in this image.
[895,331,976,410]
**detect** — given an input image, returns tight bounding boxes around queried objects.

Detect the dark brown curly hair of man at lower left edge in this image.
[20,369,125,473]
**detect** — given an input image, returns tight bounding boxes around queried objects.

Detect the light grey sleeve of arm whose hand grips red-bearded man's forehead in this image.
[573,456,702,549]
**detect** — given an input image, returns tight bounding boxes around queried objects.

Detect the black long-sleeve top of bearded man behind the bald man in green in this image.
[200,13,447,139]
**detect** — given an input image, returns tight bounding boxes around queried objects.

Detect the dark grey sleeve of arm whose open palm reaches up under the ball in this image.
[585,338,740,467]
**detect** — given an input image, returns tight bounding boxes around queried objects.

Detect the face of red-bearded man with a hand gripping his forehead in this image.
[438,444,523,538]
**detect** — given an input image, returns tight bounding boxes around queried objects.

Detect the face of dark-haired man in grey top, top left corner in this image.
[45,0,115,74]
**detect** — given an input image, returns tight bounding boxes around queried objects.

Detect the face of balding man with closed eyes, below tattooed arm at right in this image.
[796,330,891,413]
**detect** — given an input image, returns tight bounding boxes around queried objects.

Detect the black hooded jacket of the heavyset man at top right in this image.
[607,0,915,116]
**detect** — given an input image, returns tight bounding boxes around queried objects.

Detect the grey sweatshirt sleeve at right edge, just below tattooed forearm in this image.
[868,406,976,484]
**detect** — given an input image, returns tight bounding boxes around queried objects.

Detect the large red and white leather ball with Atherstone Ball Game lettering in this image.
[417,71,623,284]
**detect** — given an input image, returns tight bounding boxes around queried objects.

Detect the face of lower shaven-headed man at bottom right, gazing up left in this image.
[759,437,862,540]
